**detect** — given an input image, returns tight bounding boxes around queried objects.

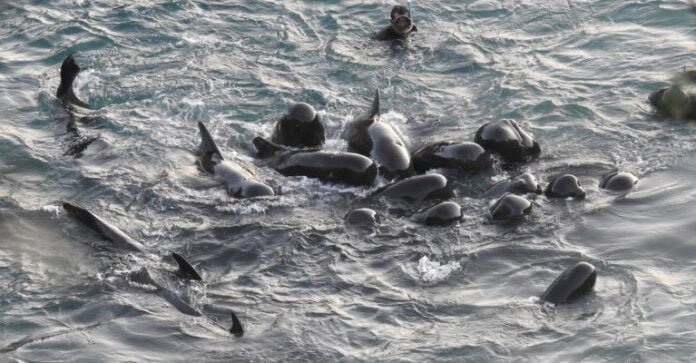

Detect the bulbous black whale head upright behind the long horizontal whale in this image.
[271,102,326,147]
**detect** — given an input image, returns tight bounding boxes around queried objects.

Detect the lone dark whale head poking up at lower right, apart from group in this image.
[540,262,597,305]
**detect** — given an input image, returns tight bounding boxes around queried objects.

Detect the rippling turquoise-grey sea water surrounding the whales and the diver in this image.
[0,0,696,362]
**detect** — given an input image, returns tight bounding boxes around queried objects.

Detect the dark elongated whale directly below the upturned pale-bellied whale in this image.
[376,174,454,202]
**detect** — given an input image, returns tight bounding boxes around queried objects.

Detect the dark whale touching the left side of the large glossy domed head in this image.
[412,141,493,173]
